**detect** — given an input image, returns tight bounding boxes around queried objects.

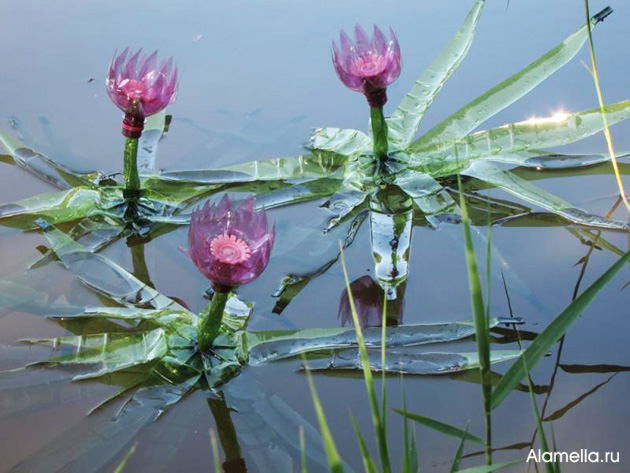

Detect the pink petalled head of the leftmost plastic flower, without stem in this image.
[106,48,177,117]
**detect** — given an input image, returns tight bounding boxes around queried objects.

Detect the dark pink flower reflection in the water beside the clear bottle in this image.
[337,275,403,327]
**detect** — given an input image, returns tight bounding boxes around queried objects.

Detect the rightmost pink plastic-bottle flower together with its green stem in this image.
[333,25,402,161]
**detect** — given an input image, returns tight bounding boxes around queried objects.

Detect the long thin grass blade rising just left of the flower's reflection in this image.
[339,242,391,473]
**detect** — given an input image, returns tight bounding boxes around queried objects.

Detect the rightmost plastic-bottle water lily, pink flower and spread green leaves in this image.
[141,0,630,300]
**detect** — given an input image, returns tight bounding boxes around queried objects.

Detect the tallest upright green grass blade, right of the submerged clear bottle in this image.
[457,175,492,465]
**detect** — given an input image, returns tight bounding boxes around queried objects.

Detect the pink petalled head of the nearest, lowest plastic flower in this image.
[188,194,275,292]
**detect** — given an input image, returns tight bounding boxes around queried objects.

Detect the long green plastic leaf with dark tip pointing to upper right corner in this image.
[418,8,612,148]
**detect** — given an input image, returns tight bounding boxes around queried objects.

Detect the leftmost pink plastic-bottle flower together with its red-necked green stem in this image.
[106,48,177,198]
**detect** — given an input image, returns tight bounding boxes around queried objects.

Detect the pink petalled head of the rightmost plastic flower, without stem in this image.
[333,25,402,106]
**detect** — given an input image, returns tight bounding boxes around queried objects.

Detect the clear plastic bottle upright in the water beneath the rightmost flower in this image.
[370,185,413,301]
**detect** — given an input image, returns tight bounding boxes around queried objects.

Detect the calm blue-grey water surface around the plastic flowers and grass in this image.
[0,0,630,473]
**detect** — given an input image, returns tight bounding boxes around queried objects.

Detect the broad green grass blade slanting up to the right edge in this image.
[492,247,630,409]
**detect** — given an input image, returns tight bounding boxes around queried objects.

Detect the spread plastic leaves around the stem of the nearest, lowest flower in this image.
[0,219,520,473]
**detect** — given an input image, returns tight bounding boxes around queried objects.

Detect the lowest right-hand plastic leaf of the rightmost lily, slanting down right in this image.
[462,161,630,230]
